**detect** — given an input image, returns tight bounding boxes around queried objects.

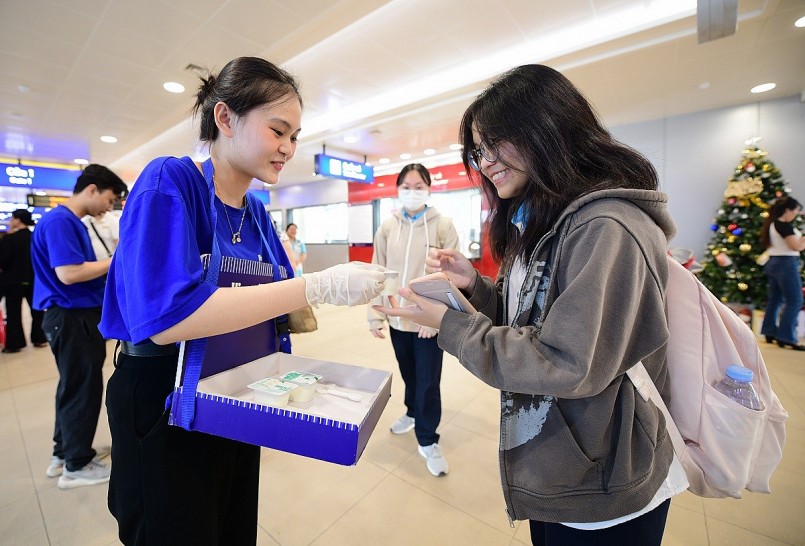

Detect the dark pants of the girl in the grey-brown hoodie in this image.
[530,499,671,546]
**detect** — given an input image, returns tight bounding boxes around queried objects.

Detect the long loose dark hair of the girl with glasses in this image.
[459,64,658,267]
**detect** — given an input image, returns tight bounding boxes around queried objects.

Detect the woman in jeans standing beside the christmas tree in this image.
[760,197,805,351]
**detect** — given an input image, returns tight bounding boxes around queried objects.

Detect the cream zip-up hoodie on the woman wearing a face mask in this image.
[367,207,458,332]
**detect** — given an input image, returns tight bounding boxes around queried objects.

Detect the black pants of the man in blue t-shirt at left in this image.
[42,307,106,471]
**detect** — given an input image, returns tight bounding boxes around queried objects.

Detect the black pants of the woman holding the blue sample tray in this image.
[106,354,260,546]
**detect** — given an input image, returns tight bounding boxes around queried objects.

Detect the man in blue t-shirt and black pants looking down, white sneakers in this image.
[31,164,128,489]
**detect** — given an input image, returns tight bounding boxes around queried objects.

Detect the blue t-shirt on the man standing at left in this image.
[31,205,104,310]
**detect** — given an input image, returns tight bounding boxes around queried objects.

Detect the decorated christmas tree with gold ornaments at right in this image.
[699,138,791,308]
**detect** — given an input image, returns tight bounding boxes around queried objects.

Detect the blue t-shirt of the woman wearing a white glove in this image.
[99,157,290,343]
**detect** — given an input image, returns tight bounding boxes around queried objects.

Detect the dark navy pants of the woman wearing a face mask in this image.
[389,328,444,446]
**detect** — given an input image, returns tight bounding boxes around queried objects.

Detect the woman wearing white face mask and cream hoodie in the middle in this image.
[369,163,458,476]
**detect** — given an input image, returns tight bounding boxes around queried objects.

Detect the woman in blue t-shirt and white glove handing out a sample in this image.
[101,57,384,545]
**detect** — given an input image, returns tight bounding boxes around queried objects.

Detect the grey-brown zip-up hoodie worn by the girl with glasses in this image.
[439,189,675,523]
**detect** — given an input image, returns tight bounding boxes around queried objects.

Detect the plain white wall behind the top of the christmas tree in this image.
[611,96,805,257]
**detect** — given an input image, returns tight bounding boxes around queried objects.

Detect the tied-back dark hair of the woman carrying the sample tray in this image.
[193,57,302,142]
